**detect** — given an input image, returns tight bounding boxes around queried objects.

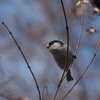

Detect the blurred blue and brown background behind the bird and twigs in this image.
[0,0,100,100]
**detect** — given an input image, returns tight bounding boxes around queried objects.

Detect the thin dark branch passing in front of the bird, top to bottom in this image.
[52,0,69,100]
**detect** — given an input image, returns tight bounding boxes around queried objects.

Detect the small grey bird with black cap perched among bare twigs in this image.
[47,40,76,82]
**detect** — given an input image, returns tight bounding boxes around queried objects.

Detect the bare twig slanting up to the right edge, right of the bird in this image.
[61,41,100,100]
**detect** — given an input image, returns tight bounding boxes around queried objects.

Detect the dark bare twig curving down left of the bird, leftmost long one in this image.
[2,22,41,100]
